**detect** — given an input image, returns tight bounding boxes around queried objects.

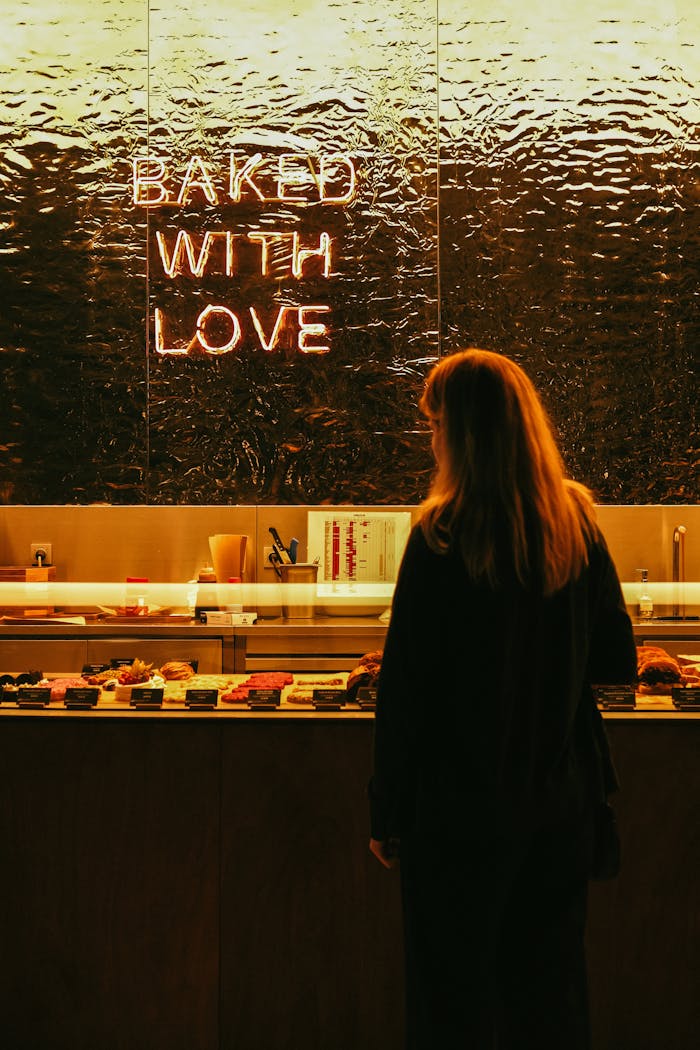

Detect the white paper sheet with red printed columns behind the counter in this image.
[309,510,410,584]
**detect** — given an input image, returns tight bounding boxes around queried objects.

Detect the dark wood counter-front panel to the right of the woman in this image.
[588,720,700,1050]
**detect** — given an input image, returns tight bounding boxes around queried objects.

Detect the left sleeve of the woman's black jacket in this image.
[368,529,427,841]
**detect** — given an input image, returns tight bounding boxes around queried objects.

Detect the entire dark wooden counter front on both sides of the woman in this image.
[0,707,700,1050]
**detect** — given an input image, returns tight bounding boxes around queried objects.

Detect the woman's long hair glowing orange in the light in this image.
[420,349,595,594]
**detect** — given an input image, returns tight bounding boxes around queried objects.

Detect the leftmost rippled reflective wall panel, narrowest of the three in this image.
[0,0,148,503]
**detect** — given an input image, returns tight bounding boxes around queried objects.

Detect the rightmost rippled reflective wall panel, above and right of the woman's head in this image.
[439,0,700,503]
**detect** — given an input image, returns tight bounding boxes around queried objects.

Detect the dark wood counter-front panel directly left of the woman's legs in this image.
[221,719,403,1050]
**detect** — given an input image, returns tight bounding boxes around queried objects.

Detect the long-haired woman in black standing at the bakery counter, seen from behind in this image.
[370,350,636,1050]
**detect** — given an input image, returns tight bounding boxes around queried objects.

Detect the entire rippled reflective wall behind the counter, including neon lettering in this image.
[0,0,700,504]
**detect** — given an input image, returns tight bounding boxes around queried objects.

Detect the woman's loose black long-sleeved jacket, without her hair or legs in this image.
[369,526,636,839]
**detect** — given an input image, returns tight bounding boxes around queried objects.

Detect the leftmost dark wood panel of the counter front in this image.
[0,715,218,1050]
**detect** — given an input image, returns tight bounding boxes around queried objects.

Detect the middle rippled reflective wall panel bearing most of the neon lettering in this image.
[143,0,438,503]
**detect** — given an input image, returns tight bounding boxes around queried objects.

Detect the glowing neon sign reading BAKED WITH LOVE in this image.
[132,151,357,356]
